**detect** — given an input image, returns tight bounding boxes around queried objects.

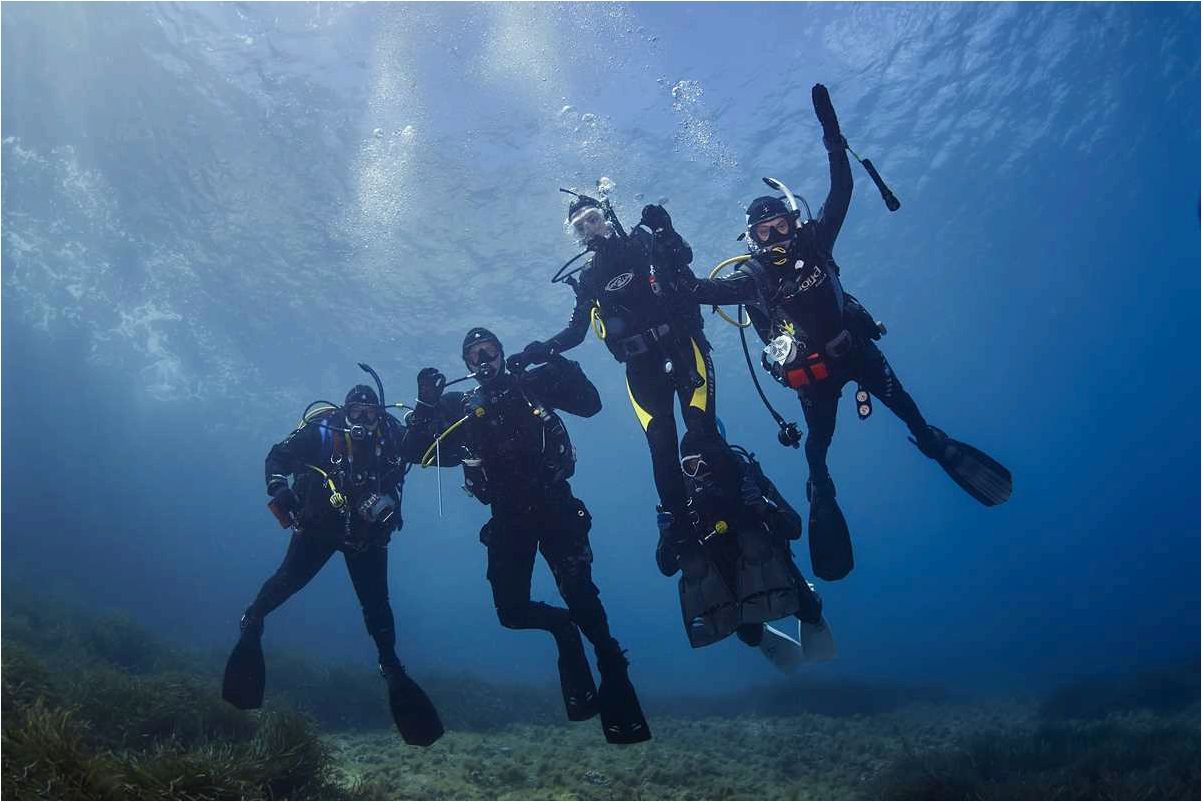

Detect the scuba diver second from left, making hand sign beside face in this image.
[407,327,651,743]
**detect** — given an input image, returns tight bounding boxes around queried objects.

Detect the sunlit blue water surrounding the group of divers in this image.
[0,4,1200,691]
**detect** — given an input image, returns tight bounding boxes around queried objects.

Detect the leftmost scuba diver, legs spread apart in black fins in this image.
[221,372,442,747]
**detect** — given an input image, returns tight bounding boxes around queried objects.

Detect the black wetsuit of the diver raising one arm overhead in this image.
[688,139,929,481]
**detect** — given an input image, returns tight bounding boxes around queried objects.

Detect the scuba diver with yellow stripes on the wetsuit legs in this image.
[510,190,718,577]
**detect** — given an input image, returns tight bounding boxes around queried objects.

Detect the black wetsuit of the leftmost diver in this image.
[246,411,407,666]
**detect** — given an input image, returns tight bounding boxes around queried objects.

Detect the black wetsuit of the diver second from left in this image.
[409,357,620,658]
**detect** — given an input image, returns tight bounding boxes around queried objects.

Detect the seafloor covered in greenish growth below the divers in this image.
[0,587,1200,800]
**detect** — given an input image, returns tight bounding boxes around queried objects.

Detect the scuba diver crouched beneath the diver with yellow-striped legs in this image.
[673,433,835,670]
